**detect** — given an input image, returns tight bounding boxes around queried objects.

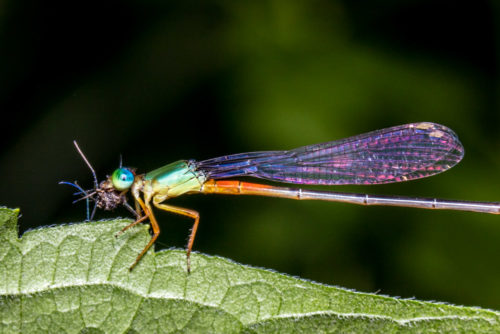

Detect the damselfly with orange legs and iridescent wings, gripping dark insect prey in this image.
[64,122,500,273]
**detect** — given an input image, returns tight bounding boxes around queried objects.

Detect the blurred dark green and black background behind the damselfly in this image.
[0,0,500,309]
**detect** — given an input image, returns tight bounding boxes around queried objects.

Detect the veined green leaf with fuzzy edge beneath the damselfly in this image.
[0,208,500,333]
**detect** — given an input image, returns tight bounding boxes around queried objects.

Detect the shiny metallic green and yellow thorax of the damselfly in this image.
[144,160,206,197]
